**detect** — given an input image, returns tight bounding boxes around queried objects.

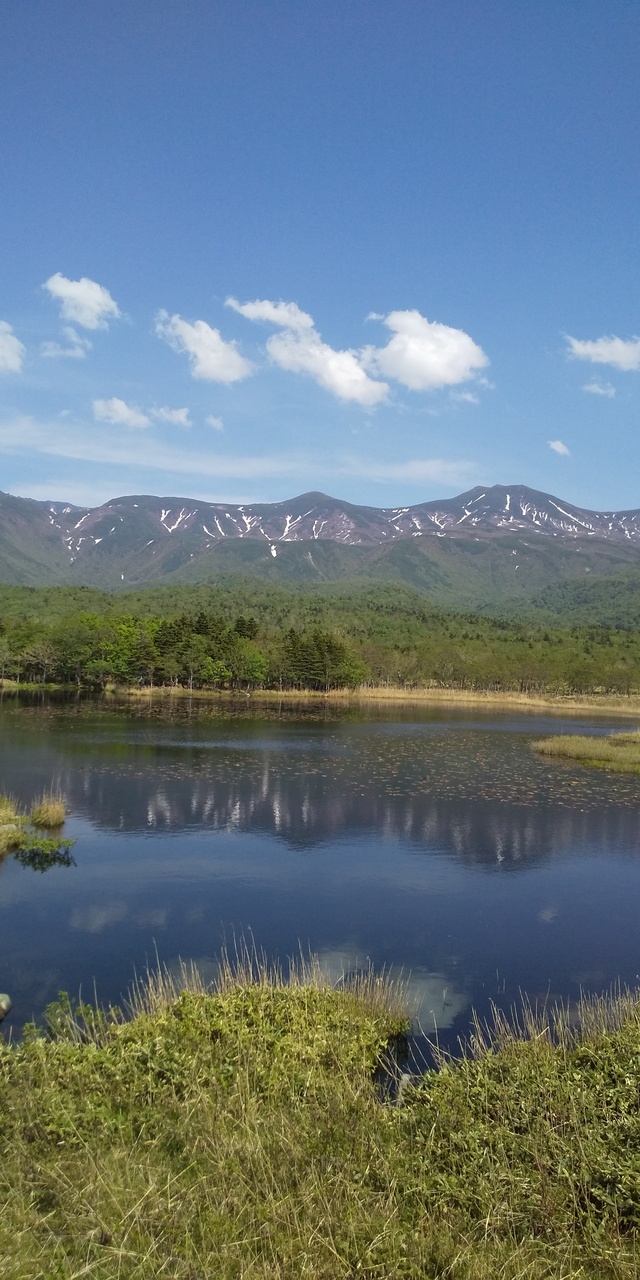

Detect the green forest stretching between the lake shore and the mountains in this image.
[0,581,640,694]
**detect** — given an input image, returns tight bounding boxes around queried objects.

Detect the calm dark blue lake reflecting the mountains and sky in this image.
[0,698,640,1046]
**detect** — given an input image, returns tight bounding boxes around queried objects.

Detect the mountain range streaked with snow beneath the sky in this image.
[0,485,640,609]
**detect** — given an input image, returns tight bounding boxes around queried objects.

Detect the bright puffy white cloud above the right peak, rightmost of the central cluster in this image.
[361,311,489,392]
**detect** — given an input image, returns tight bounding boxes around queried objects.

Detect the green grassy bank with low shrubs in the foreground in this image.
[0,973,640,1280]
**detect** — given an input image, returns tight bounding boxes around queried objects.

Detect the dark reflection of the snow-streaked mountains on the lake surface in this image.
[49,760,640,868]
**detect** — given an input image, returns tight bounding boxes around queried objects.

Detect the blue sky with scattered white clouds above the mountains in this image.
[0,0,640,509]
